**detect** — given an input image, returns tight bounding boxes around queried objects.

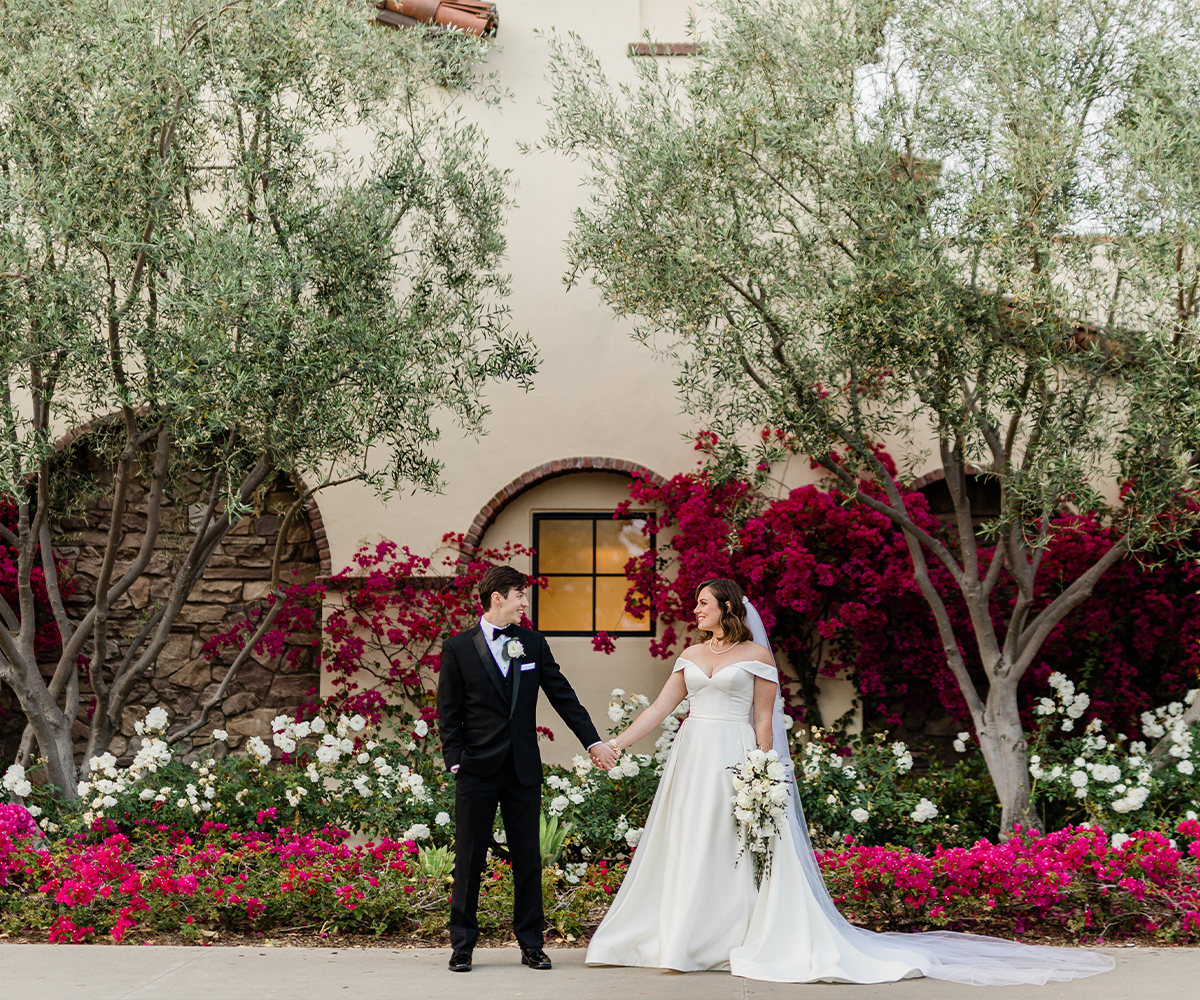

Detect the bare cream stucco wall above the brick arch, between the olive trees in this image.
[320,0,710,571]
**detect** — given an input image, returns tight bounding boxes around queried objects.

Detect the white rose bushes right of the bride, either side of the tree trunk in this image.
[792,673,1200,849]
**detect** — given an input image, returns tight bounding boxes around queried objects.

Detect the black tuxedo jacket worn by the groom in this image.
[438,625,600,785]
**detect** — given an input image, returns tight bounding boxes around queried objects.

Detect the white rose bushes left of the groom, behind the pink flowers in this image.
[4,707,454,845]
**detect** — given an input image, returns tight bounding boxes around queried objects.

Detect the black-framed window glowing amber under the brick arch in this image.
[533,514,654,635]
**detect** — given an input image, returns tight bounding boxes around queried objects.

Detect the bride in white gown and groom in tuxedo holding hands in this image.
[438,567,1114,986]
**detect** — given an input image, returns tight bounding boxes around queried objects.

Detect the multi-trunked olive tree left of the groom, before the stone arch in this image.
[0,0,535,797]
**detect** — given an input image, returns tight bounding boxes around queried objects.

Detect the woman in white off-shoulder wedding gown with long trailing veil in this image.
[587,580,1115,986]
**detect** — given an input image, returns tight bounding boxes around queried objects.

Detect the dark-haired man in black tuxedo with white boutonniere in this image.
[438,565,617,972]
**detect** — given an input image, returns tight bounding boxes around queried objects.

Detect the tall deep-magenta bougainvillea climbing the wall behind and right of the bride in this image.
[626,454,1200,733]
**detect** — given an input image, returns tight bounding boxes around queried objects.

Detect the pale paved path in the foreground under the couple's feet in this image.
[0,945,1200,1000]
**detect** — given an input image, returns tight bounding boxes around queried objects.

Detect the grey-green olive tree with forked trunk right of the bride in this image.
[541,0,1200,831]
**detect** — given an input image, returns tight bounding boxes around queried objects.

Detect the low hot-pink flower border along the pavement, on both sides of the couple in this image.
[0,820,1200,944]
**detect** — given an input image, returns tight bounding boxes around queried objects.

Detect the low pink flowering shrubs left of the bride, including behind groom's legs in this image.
[0,824,623,942]
